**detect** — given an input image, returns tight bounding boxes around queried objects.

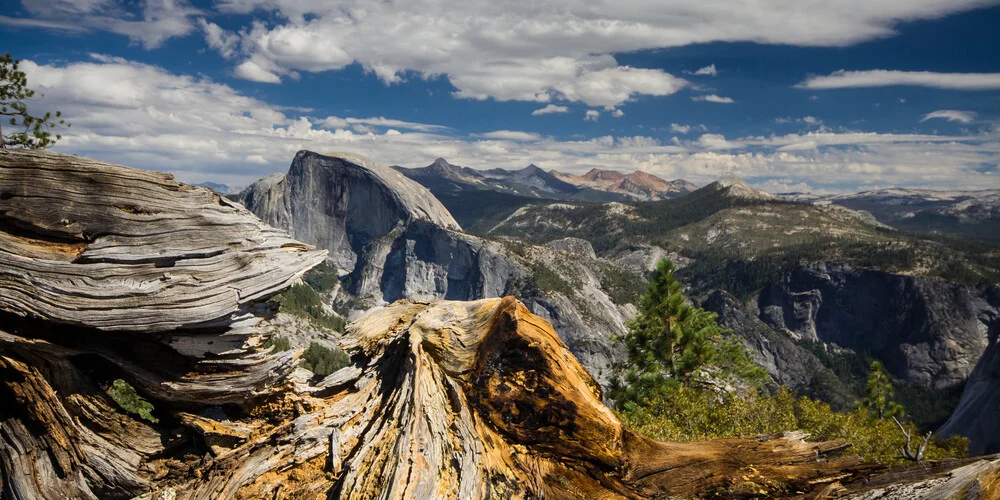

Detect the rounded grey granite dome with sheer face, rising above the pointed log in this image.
[240,151,459,269]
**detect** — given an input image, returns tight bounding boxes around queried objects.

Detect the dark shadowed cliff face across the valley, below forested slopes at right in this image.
[758,264,1000,389]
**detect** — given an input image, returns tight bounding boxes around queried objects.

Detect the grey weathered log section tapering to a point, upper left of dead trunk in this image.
[0,150,325,332]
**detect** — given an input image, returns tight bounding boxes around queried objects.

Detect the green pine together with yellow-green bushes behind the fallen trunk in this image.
[609,260,968,464]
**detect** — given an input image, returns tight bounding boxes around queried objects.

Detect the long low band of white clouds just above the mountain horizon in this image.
[22,57,1000,190]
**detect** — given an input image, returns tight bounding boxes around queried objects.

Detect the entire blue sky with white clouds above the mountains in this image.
[0,0,1000,193]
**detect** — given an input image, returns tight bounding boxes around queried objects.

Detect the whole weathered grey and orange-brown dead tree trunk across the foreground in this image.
[0,153,1000,499]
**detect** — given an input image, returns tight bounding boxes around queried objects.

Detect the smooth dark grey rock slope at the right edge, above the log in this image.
[940,287,1000,455]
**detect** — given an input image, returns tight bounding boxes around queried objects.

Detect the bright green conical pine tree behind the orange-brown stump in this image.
[608,259,768,405]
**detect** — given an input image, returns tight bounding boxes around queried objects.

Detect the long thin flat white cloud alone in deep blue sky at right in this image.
[796,69,1000,90]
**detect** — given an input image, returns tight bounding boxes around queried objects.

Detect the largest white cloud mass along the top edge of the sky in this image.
[188,0,983,105]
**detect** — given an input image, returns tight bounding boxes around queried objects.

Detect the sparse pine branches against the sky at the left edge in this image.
[0,53,70,149]
